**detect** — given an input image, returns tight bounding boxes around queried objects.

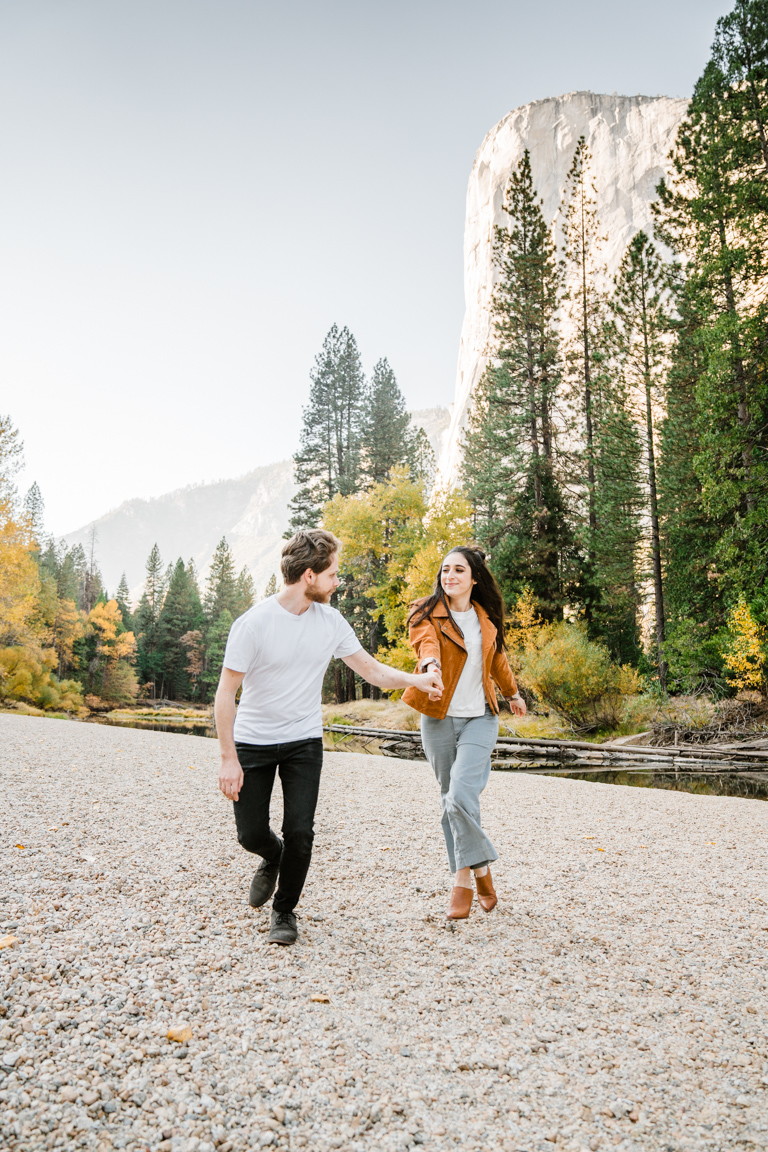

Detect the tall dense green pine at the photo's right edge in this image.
[656,49,768,596]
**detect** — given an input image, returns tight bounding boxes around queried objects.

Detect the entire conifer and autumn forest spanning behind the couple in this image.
[0,0,768,730]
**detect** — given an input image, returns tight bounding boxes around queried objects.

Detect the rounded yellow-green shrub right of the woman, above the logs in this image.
[520,623,640,732]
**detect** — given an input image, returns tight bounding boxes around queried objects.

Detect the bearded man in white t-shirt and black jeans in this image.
[215,529,442,945]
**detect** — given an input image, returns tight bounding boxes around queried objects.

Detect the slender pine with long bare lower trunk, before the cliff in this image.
[610,232,670,691]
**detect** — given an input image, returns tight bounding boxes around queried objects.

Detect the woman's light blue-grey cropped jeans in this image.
[421,704,499,872]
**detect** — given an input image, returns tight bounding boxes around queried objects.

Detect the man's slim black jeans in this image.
[234,736,322,912]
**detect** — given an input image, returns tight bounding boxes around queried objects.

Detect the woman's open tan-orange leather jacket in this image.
[403,600,517,720]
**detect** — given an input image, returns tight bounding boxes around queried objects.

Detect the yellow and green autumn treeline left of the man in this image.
[0,417,264,712]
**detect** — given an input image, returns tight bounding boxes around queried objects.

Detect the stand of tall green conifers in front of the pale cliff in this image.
[455,0,768,690]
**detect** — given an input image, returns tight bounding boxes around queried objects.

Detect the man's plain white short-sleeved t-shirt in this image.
[225,596,363,744]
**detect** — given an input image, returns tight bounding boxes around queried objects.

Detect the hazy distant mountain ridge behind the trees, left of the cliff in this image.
[63,408,450,599]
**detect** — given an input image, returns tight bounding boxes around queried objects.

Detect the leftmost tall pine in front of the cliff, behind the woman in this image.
[463,151,575,619]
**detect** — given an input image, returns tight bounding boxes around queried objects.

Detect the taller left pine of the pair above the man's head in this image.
[286,324,366,536]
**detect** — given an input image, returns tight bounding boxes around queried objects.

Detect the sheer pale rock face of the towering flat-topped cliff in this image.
[440,92,689,483]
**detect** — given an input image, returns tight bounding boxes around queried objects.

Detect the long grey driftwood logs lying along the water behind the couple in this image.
[324,725,768,772]
